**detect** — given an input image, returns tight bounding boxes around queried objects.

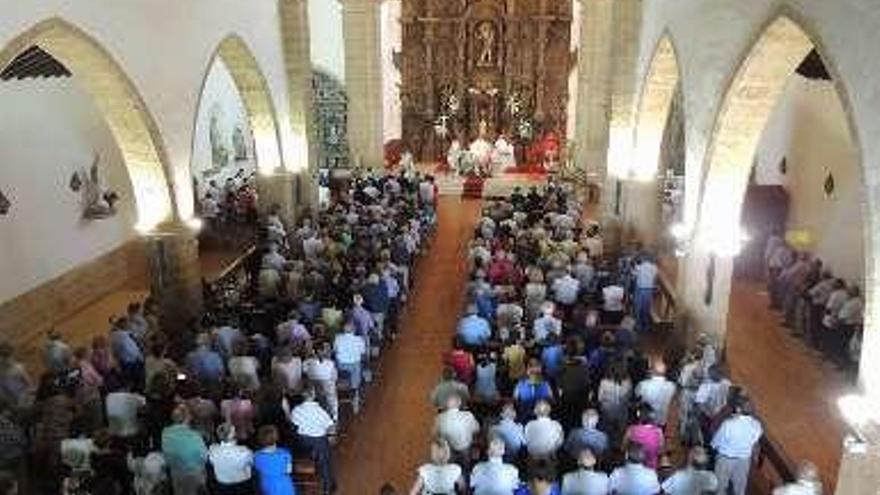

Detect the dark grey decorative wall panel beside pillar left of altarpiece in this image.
[312,70,349,169]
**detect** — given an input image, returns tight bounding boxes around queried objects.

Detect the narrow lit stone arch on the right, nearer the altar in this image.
[631,32,682,180]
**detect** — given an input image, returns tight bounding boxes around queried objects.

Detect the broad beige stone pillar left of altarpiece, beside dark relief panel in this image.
[342,0,385,168]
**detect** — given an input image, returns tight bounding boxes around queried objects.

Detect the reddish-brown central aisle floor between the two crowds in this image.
[334,196,480,495]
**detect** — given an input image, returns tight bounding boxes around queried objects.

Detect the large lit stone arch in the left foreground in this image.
[0,18,179,232]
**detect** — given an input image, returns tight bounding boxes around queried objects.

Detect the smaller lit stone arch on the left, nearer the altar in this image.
[193,34,284,175]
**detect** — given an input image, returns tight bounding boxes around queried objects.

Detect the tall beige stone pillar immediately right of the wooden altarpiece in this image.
[574,0,614,196]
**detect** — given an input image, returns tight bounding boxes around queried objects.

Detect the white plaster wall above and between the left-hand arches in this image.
[0,0,302,221]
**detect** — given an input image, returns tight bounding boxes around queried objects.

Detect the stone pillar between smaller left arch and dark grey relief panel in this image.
[279,0,318,210]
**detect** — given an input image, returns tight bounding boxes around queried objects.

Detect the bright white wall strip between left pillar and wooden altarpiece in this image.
[380,0,403,143]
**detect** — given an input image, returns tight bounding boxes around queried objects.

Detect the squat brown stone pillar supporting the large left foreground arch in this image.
[144,222,202,335]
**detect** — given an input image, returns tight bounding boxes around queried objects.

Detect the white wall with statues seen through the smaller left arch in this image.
[192,58,256,197]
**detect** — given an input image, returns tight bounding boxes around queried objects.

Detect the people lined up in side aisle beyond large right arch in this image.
[764,234,865,373]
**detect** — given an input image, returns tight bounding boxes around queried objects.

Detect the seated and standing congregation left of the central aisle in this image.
[0,170,436,495]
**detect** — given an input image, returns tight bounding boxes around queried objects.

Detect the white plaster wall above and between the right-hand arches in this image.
[636,0,880,360]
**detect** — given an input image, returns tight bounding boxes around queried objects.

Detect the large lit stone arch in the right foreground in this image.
[688,13,877,362]
